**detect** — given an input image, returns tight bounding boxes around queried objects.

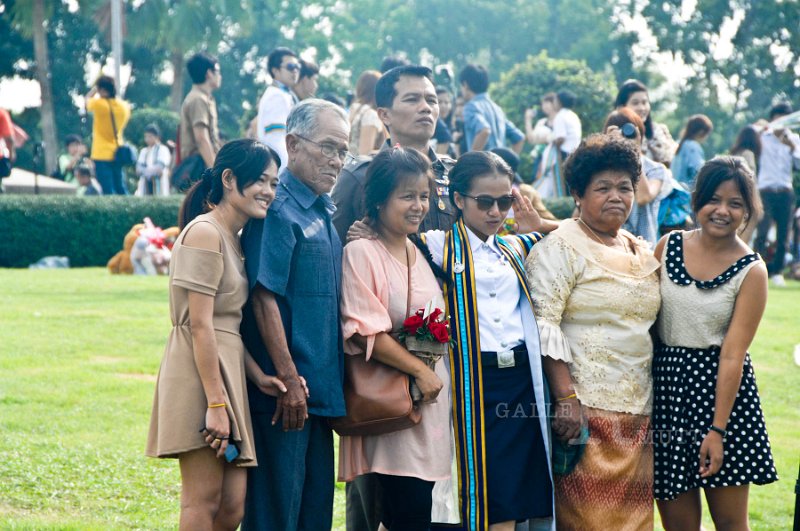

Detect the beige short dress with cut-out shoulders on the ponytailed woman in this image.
[146,214,257,466]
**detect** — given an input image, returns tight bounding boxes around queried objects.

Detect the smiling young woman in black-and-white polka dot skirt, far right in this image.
[653,157,778,531]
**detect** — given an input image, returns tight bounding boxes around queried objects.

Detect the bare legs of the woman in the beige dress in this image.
[179,448,247,531]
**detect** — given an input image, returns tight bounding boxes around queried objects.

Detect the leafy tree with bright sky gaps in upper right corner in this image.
[642,0,800,153]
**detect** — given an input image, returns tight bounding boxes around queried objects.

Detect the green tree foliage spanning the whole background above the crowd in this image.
[0,0,800,170]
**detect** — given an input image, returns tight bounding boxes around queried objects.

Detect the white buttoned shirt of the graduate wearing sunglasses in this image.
[425,229,525,352]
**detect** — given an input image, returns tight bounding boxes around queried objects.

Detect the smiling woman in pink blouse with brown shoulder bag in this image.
[339,147,452,531]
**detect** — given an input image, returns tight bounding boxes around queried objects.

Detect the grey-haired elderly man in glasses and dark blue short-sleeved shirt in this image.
[242,98,350,531]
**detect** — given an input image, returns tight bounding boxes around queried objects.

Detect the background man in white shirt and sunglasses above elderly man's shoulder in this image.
[256,47,301,168]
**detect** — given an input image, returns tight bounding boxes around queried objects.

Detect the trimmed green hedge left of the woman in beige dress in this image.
[0,195,183,267]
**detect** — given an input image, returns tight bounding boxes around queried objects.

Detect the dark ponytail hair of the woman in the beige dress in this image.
[178,138,281,230]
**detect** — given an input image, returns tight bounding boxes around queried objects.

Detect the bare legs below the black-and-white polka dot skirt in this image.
[657,485,750,531]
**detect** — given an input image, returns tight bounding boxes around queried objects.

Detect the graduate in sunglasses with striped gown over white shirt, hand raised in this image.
[422,152,555,530]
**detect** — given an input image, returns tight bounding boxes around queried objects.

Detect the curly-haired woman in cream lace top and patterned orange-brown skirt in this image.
[526,135,661,531]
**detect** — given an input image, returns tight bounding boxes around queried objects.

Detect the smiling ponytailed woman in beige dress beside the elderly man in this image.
[147,139,285,529]
